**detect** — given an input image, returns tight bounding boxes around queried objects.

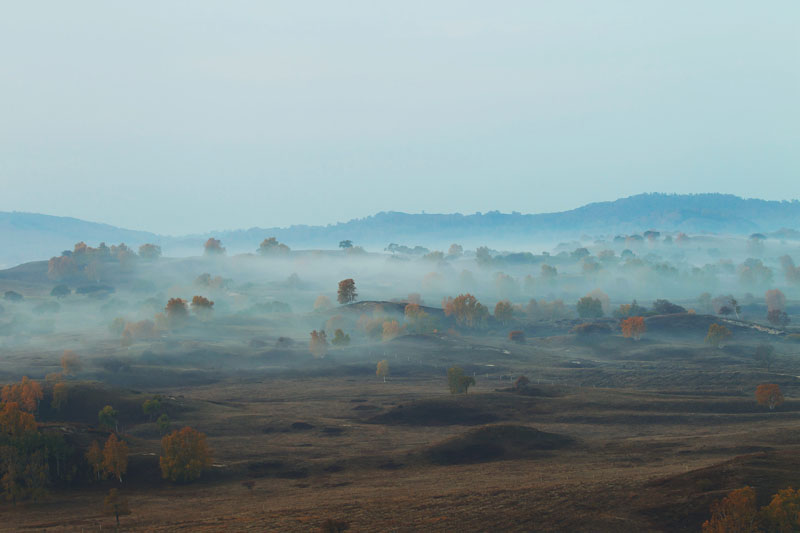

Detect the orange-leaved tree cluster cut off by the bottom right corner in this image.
[703,487,800,533]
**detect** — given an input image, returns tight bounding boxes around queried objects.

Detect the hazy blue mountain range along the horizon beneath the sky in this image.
[0,194,800,267]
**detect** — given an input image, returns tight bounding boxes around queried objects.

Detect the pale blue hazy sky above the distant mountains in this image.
[0,0,800,234]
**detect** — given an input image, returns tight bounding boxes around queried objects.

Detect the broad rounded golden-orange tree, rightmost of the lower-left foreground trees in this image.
[158,426,211,482]
